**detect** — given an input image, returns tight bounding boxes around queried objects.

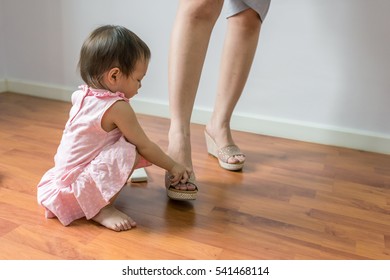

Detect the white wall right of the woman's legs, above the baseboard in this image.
[247,0,390,134]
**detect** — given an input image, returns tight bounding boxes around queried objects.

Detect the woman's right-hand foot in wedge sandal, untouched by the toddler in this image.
[205,124,245,165]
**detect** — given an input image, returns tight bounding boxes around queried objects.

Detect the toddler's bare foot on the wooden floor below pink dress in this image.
[92,204,137,231]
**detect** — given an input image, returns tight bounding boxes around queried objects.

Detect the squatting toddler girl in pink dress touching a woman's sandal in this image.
[37,25,194,231]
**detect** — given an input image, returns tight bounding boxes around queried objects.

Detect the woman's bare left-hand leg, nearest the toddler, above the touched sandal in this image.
[168,0,223,186]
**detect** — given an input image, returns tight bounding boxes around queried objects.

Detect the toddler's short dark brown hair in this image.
[78,25,151,88]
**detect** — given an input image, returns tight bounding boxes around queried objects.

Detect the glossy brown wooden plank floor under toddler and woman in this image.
[0,93,390,260]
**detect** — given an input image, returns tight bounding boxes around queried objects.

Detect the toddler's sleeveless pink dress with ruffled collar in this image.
[37,86,150,226]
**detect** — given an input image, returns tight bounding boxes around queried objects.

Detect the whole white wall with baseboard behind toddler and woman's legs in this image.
[0,0,390,153]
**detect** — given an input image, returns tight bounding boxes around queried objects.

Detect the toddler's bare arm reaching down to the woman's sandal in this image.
[102,101,189,185]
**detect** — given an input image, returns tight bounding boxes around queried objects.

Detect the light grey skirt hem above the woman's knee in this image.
[225,0,271,21]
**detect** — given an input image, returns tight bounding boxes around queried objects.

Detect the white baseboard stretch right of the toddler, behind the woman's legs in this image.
[132,100,390,154]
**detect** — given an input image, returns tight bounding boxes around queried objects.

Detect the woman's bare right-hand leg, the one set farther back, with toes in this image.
[206,9,261,163]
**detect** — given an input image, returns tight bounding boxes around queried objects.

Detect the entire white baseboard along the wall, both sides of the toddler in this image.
[0,80,390,154]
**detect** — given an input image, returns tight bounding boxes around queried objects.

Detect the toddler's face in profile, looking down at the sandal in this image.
[118,60,149,99]
